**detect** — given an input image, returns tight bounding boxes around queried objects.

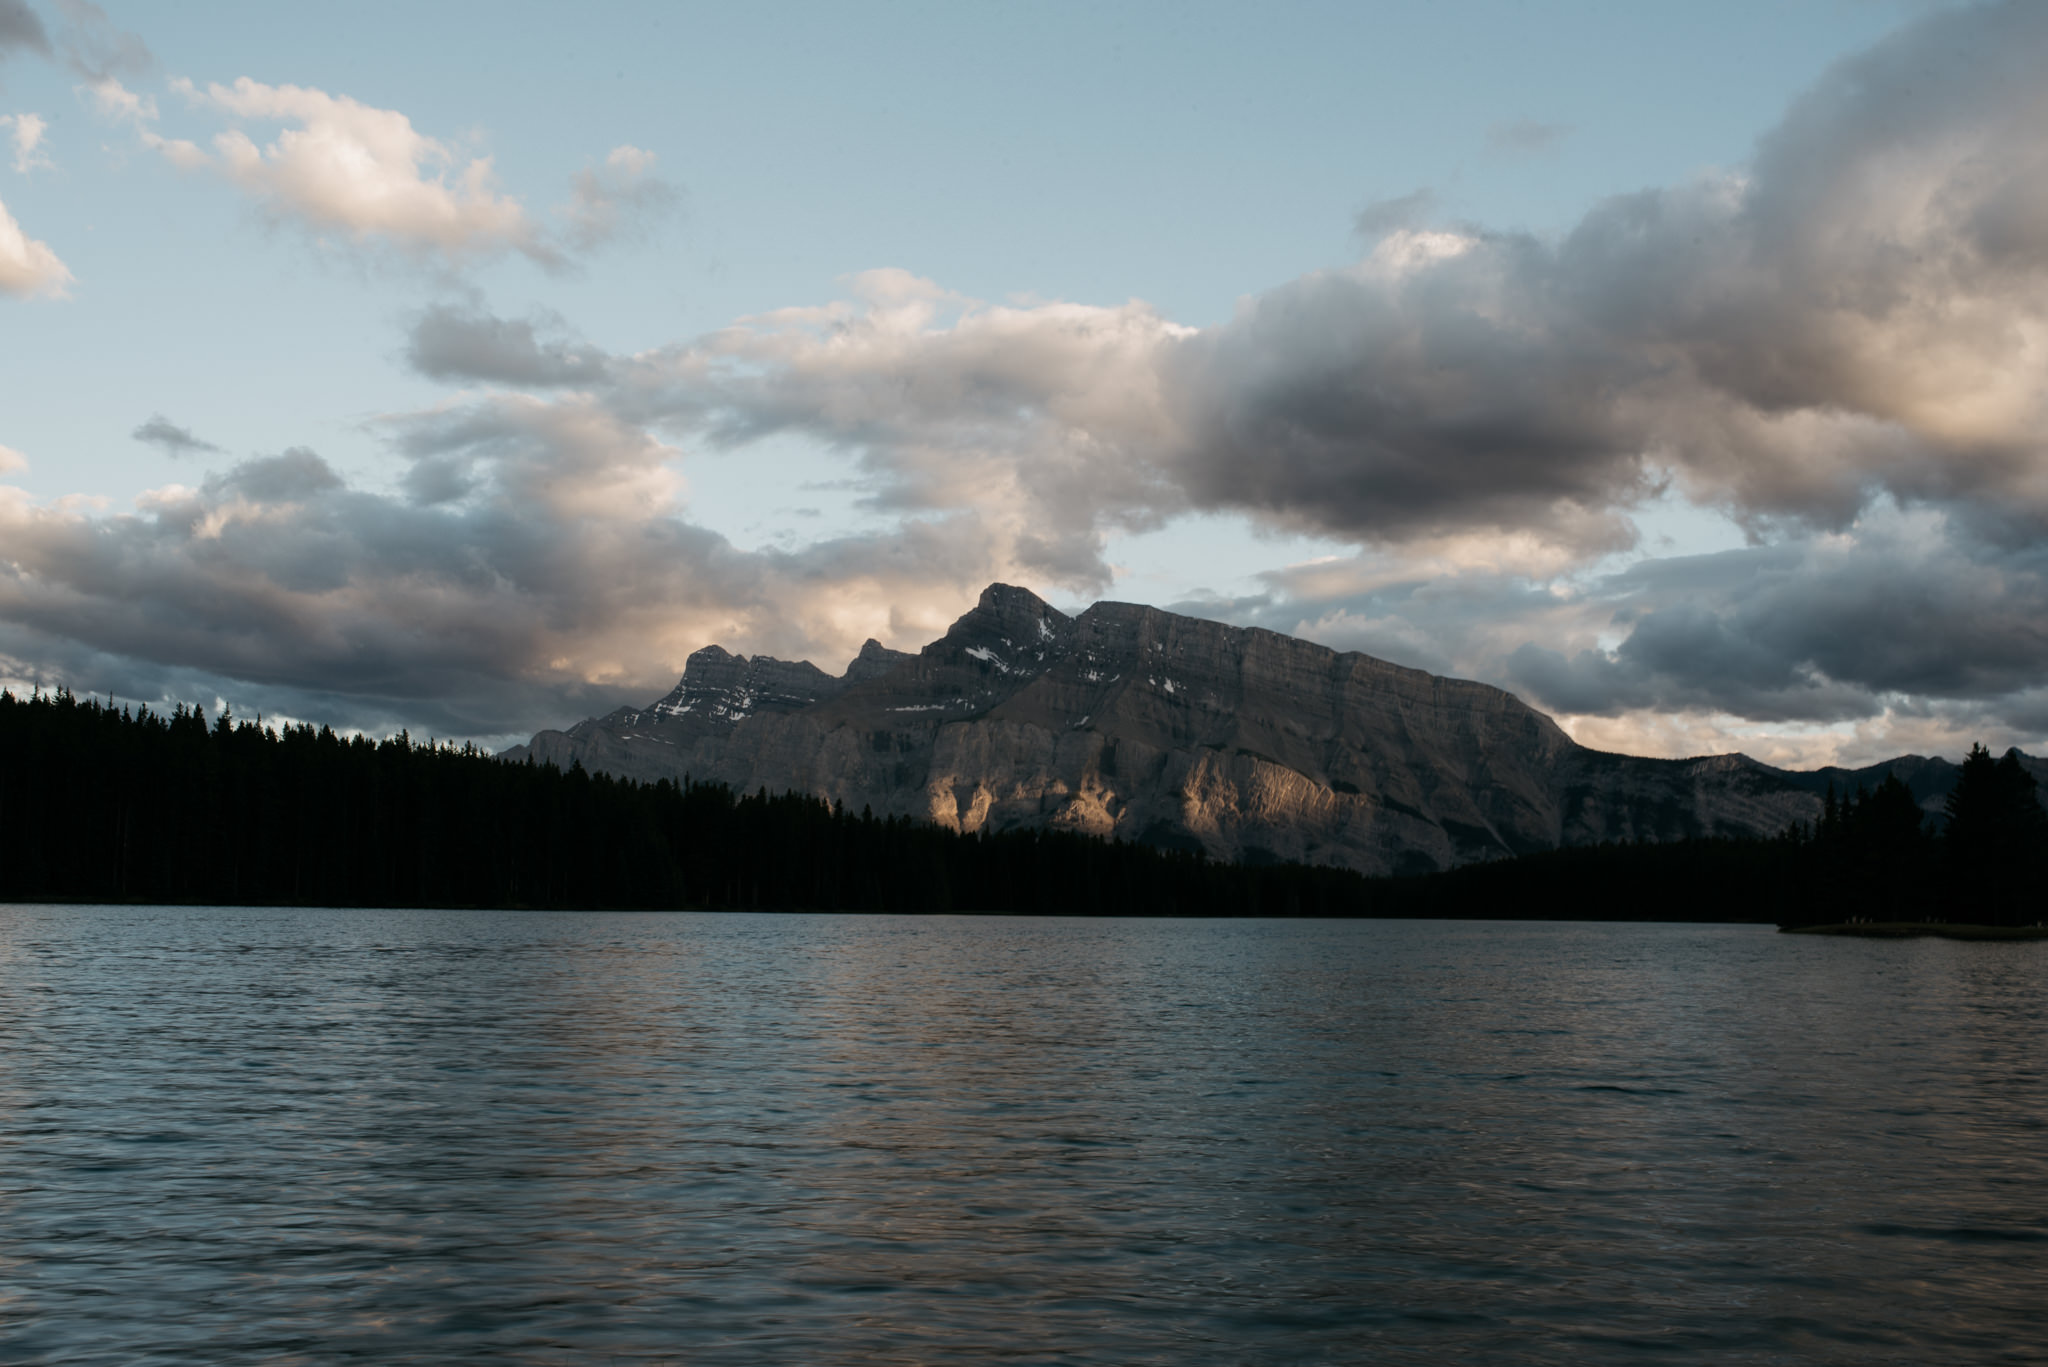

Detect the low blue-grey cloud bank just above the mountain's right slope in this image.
[1178,504,2048,767]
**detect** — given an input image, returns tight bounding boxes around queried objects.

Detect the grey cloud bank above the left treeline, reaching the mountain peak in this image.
[0,396,1048,738]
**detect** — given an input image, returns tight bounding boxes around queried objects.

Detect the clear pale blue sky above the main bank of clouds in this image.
[12,2,1898,500]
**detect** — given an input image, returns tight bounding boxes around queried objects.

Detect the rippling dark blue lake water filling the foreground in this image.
[0,908,2048,1365]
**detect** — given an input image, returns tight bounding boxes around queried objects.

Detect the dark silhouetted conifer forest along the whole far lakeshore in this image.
[0,691,2048,924]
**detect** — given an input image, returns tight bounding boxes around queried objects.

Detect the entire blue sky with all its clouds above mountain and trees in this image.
[0,0,2048,767]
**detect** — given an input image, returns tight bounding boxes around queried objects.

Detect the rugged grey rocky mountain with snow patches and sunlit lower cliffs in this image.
[506,584,2048,873]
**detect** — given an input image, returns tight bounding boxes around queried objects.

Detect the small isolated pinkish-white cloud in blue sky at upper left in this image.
[145,76,561,266]
